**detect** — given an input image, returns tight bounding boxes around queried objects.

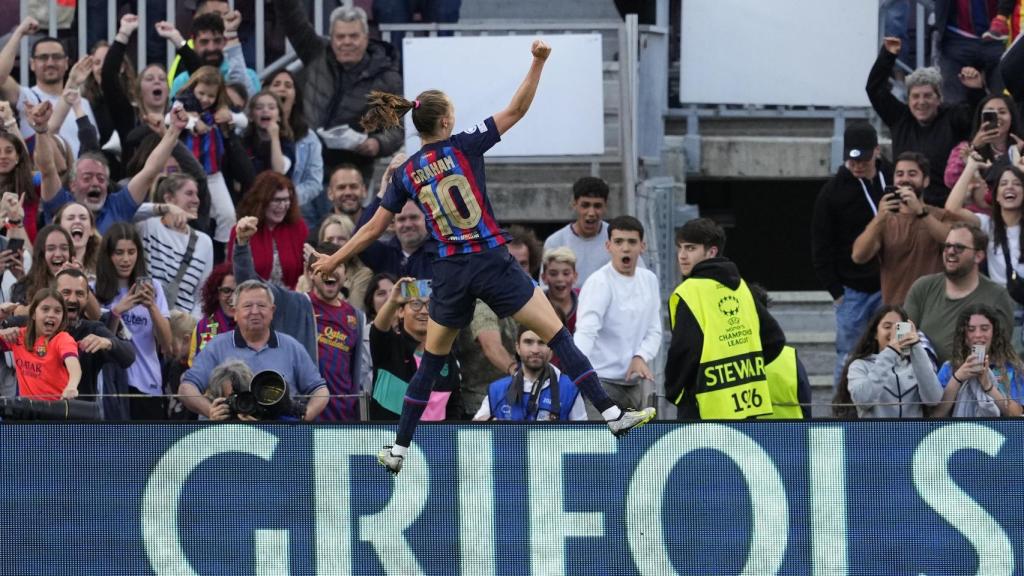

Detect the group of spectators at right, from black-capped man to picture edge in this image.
[812,1,1024,418]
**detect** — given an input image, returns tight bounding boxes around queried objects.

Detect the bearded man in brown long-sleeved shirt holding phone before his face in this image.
[851,152,962,304]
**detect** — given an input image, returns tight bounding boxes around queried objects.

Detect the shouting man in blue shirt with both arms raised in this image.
[27,102,188,234]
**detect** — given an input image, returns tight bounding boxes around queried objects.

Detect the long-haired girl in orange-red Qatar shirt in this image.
[0,288,82,401]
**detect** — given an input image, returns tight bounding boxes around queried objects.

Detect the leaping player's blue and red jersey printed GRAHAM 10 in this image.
[381,118,506,257]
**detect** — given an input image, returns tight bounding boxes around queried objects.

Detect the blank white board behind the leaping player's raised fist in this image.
[402,34,604,156]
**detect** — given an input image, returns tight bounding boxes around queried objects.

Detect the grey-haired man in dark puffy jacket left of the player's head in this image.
[273,2,403,181]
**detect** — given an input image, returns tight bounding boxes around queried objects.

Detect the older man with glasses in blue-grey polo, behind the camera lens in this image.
[178,280,329,421]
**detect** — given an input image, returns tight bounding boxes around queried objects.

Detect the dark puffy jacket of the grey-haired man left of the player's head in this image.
[273,2,404,156]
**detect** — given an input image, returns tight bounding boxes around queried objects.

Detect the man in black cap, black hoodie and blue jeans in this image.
[811,122,893,383]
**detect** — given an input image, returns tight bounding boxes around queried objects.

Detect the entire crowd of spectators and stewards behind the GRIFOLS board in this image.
[6,0,1024,420]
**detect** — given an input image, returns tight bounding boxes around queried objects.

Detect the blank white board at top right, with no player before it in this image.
[679,0,879,107]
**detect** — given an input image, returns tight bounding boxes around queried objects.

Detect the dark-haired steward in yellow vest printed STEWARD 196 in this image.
[665,218,785,420]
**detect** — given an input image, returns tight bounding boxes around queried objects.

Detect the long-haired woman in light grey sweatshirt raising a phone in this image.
[835,304,942,418]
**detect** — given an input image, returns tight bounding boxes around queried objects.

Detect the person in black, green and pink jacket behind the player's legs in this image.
[370,278,462,421]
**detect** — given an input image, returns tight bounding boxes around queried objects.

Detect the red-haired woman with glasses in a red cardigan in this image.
[227,171,301,290]
